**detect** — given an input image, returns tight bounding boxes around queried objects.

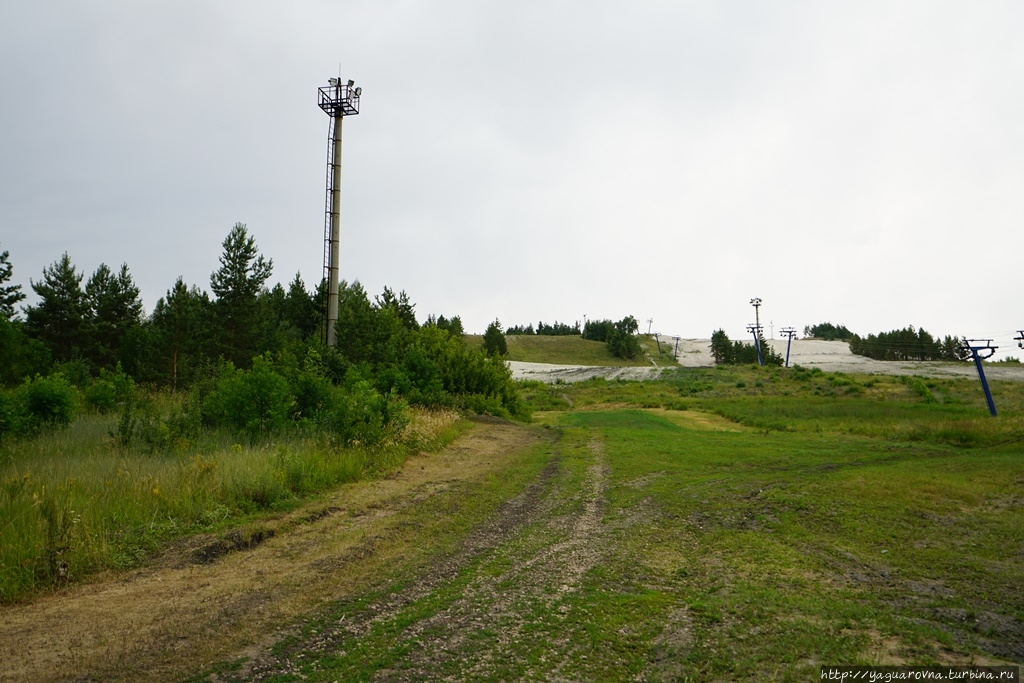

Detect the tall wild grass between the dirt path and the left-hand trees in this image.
[0,411,460,602]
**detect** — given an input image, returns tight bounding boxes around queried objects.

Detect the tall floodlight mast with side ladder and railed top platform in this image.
[318,78,362,346]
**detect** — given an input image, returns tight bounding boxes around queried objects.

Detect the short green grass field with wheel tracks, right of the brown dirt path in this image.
[194,368,1024,681]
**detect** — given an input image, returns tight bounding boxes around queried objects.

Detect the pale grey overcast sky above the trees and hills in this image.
[0,0,1024,355]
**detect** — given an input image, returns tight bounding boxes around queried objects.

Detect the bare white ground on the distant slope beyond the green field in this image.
[509,339,1024,383]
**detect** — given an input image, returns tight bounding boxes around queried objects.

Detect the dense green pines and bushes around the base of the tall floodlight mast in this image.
[0,223,525,435]
